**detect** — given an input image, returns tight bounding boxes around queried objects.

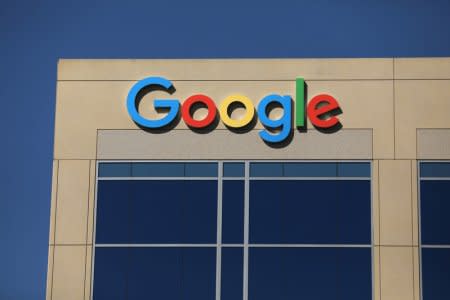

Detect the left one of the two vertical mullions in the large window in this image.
[216,161,223,300]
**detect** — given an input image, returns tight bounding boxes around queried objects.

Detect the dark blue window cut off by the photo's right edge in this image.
[419,161,450,300]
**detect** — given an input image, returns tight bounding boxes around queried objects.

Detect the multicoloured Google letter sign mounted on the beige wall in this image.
[127,77,341,143]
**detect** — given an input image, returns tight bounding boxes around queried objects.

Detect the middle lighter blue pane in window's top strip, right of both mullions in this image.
[284,163,337,177]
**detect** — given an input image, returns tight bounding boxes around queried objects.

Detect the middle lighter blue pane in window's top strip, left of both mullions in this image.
[131,163,184,177]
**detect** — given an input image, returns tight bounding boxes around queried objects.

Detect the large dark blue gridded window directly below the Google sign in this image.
[93,161,373,300]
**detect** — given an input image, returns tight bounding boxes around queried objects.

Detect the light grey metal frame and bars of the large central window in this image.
[90,159,372,300]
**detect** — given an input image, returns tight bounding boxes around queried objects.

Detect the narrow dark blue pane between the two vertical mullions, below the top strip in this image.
[222,180,245,244]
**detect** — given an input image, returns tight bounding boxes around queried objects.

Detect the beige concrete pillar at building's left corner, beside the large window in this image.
[47,160,96,300]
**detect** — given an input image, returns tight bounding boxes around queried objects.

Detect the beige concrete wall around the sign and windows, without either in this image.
[47,58,450,300]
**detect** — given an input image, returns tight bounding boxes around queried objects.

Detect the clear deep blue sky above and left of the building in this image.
[0,0,450,299]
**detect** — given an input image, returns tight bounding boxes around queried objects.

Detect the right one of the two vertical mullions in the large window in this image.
[242,161,250,300]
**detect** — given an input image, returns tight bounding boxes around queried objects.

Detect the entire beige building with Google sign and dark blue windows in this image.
[47,58,450,300]
